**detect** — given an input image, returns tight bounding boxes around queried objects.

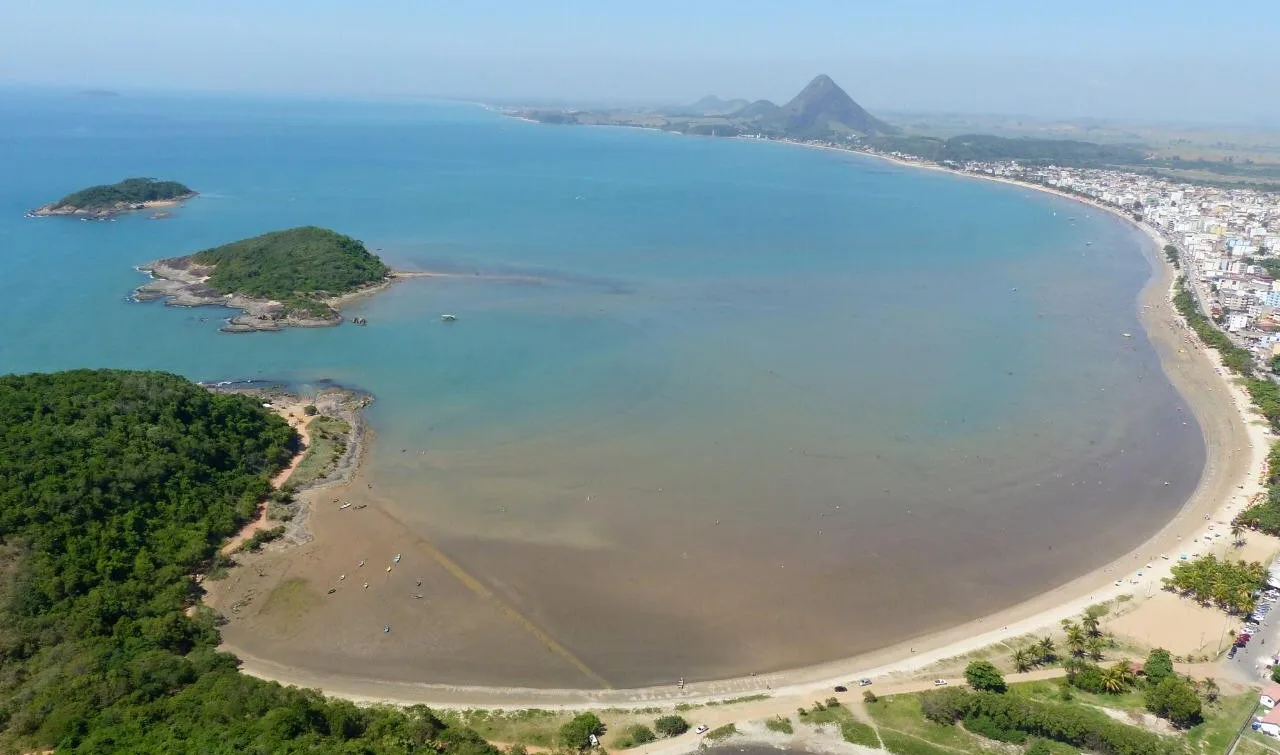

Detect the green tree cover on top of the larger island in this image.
[192,225,390,317]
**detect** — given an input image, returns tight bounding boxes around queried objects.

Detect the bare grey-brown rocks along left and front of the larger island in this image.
[133,257,342,333]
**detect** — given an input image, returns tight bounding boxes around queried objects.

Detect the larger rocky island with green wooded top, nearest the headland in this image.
[133,225,396,333]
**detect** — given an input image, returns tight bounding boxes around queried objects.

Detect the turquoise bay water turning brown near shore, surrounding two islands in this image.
[0,92,1204,685]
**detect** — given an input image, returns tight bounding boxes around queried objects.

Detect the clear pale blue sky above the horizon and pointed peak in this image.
[0,0,1280,124]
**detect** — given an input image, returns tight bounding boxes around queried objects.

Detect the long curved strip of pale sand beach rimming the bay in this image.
[214,163,1270,709]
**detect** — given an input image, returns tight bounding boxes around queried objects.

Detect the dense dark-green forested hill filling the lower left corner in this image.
[0,370,497,755]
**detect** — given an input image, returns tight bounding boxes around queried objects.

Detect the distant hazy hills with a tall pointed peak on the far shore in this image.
[520,74,899,139]
